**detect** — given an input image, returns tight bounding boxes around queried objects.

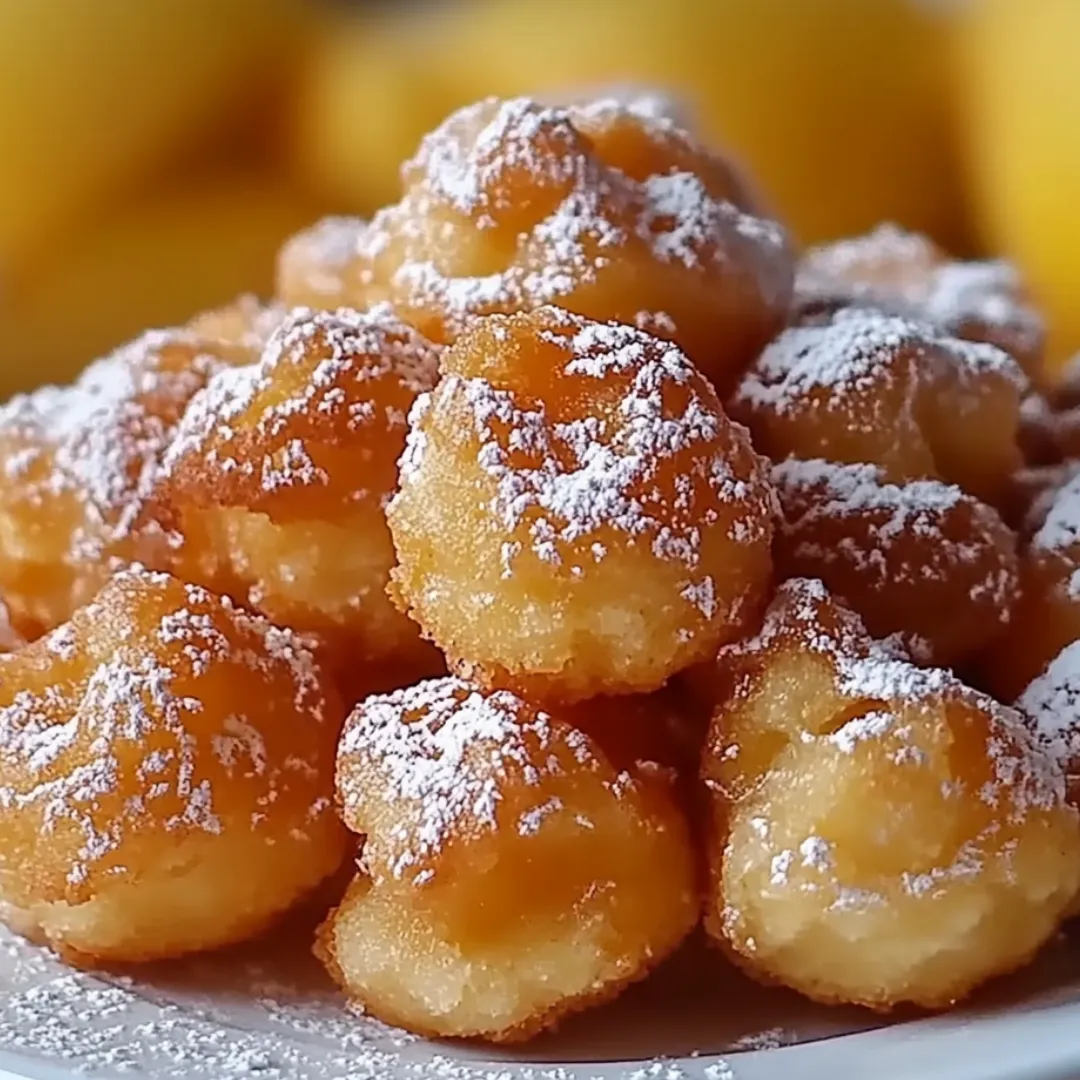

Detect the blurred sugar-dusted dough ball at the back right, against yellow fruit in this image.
[795,225,1047,378]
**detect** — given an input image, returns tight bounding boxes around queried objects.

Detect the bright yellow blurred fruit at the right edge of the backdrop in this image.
[957,0,1080,360]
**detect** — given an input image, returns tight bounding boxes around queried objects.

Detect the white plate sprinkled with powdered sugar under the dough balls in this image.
[0,927,1080,1080]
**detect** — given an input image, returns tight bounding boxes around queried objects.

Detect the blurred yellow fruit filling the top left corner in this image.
[0,0,302,274]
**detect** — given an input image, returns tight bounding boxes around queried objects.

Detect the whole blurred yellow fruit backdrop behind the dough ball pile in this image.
[0,0,1080,393]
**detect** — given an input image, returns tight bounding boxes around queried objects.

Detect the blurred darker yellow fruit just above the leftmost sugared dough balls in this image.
[0,173,322,396]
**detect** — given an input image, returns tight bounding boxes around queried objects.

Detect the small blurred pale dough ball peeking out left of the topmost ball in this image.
[276,217,367,308]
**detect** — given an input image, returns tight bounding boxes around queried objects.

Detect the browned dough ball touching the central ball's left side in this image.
[157,307,445,691]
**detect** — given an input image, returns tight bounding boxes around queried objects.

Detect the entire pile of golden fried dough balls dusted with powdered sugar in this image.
[0,99,1080,1041]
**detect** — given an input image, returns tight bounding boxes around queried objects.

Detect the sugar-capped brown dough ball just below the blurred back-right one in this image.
[728,308,1026,504]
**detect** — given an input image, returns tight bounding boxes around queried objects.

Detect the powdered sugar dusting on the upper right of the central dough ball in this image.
[401,312,773,591]
